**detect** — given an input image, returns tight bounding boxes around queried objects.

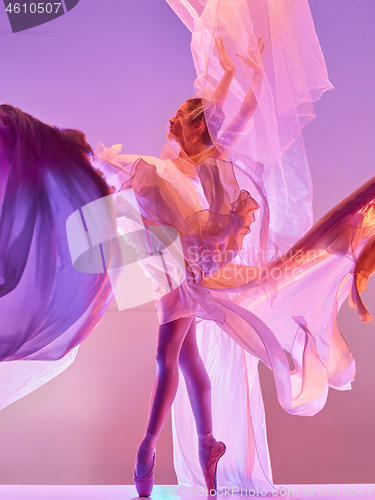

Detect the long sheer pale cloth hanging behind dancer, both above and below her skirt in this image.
[164,0,332,487]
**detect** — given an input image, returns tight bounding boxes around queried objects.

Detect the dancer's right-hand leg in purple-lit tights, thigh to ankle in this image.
[179,320,216,469]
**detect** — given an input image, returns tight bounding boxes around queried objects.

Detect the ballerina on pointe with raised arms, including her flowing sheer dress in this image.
[89,33,374,496]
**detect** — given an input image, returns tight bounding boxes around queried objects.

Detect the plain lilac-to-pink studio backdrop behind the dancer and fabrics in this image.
[0,0,375,484]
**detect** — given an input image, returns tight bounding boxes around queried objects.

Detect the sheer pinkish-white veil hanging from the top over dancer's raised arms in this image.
[167,0,332,261]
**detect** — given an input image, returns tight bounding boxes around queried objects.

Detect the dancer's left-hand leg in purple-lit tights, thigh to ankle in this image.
[136,318,192,477]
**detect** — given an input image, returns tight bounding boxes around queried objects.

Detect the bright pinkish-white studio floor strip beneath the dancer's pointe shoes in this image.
[0,484,375,500]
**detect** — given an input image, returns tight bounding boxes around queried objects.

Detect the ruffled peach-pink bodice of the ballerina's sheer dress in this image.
[119,154,259,282]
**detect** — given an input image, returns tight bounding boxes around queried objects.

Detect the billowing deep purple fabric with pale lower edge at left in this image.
[0,105,112,407]
